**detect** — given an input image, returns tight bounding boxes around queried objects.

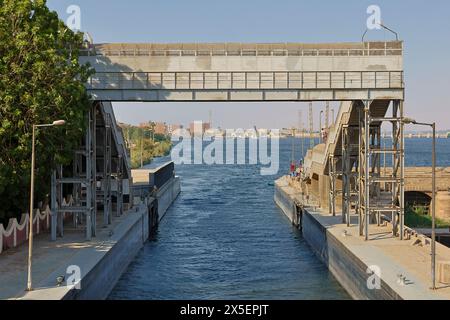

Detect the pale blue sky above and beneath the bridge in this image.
[48,0,450,129]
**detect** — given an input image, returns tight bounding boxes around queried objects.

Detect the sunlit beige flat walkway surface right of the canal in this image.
[276,178,450,300]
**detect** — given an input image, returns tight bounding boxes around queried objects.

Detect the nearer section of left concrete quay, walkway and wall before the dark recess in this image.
[0,206,148,300]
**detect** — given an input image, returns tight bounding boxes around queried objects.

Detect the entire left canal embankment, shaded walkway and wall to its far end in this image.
[0,168,180,300]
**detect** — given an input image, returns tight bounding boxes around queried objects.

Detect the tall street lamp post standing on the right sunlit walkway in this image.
[403,118,436,290]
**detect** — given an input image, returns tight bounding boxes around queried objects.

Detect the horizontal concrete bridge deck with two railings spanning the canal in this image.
[80,41,404,101]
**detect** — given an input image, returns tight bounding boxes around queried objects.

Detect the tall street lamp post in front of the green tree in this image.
[27,120,66,291]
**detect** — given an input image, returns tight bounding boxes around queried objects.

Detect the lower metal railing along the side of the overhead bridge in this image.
[87,71,404,90]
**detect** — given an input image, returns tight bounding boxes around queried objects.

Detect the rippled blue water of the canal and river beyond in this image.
[109,139,450,300]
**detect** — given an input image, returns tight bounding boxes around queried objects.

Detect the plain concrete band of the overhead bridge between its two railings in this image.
[80,55,403,72]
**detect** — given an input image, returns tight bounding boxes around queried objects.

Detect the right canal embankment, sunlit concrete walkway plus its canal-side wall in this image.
[274,177,450,300]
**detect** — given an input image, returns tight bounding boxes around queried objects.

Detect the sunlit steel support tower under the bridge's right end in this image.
[358,100,404,240]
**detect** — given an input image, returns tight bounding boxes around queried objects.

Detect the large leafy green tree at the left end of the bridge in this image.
[0,0,91,222]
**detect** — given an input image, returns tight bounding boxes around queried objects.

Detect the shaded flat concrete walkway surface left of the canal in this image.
[0,209,142,300]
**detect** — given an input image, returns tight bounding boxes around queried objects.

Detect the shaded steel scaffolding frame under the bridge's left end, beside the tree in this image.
[51,103,124,241]
